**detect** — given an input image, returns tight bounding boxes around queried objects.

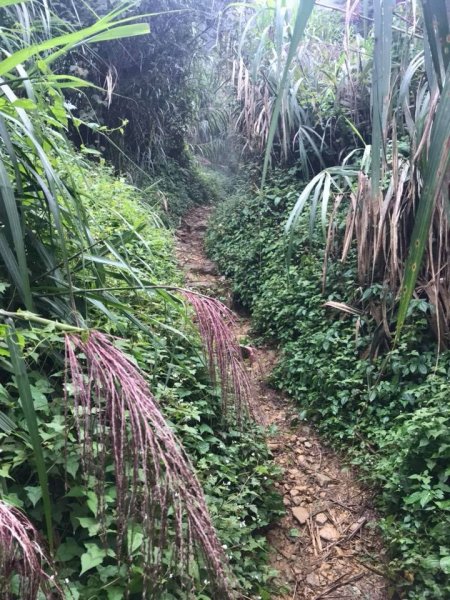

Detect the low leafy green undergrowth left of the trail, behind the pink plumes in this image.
[0,155,279,600]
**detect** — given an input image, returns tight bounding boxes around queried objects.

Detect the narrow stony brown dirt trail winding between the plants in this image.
[177,206,388,600]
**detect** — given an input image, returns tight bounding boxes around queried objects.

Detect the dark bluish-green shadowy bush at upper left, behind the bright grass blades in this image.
[52,0,227,171]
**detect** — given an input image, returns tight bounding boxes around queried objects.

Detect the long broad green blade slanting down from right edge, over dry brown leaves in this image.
[396,69,450,339]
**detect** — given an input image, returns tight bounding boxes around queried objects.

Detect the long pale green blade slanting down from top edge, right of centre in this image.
[261,0,315,189]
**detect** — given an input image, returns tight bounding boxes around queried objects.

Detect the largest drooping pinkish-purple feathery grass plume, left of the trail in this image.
[65,331,237,599]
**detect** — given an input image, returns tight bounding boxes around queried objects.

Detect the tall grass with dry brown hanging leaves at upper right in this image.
[234,0,450,346]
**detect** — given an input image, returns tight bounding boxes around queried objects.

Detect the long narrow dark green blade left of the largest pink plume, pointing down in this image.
[7,319,53,551]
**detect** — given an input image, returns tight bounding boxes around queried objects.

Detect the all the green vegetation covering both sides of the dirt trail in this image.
[0,0,450,600]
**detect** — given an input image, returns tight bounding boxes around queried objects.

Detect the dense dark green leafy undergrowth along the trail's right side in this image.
[208,169,450,600]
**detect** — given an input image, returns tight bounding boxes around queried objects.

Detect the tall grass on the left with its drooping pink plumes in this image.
[0,5,253,600]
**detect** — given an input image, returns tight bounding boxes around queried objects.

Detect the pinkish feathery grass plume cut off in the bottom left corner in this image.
[0,500,62,600]
